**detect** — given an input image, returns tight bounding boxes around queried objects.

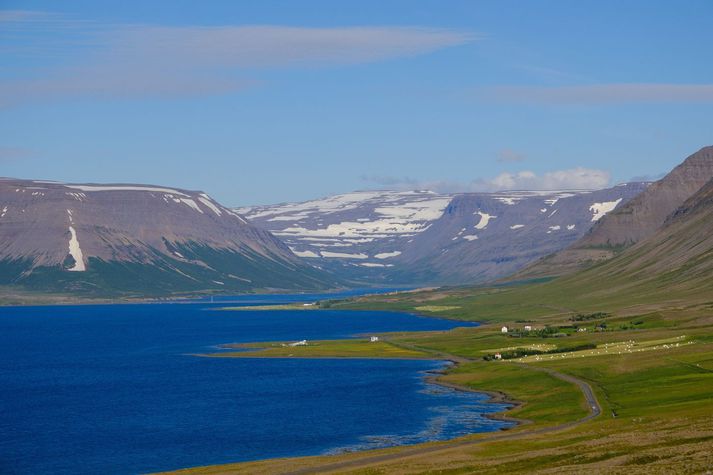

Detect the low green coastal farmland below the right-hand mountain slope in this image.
[163,284,713,474]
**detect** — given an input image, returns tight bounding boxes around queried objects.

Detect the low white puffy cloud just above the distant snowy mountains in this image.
[361,167,611,193]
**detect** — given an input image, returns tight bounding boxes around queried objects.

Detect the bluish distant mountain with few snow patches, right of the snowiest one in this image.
[391,183,646,284]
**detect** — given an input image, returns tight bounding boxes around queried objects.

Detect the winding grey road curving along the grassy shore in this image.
[285,345,602,475]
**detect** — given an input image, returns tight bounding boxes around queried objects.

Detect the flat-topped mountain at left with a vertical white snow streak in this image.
[0,179,334,295]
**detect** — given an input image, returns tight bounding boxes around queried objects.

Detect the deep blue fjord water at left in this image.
[0,297,508,474]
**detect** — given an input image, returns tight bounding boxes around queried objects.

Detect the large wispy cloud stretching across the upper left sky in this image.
[0,11,477,105]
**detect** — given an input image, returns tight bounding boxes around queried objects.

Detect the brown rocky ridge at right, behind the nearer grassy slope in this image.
[518,146,713,278]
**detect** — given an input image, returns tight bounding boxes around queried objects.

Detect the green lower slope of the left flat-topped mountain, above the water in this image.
[0,243,340,303]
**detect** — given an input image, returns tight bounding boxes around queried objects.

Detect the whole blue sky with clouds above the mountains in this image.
[0,0,713,206]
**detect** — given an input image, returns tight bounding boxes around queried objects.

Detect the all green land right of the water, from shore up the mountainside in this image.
[159,148,713,474]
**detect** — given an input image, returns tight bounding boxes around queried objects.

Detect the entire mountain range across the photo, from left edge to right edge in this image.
[0,147,713,296]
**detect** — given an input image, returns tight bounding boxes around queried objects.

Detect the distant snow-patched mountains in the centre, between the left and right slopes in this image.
[238,183,646,284]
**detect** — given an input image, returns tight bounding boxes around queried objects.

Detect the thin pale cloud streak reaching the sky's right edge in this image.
[478,83,713,104]
